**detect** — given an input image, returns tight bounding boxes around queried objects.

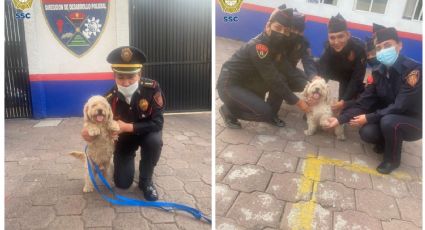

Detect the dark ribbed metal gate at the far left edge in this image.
[4,1,32,118]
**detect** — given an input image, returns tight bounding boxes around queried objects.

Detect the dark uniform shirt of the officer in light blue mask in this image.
[338,55,422,124]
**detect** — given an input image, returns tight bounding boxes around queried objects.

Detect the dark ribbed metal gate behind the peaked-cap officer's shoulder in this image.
[129,0,211,111]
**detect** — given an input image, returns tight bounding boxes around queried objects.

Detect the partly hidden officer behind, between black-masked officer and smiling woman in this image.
[277,11,318,92]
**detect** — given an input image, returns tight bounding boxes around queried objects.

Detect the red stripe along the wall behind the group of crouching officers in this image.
[238,3,422,41]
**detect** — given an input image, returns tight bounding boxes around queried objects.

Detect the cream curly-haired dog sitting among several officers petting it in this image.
[303,78,345,140]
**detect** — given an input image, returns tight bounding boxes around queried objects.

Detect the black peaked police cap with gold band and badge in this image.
[106,46,146,74]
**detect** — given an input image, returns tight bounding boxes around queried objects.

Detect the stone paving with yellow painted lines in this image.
[215,37,422,230]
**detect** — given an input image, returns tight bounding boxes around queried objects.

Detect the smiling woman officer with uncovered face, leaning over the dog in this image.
[319,14,366,111]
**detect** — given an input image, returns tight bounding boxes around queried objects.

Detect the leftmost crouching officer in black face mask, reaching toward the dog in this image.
[217,9,309,128]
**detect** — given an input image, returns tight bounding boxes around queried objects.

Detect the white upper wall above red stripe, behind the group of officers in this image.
[244,0,422,34]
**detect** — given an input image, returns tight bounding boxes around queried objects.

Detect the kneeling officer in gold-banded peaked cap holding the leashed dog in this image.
[83,46,164,201]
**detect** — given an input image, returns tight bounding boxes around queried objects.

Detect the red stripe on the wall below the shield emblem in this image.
[30,72,114,82]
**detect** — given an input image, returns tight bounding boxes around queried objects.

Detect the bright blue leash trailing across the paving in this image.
[84,146,211,224]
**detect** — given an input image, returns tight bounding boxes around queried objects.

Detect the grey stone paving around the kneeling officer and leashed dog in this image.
[5,113,211,230]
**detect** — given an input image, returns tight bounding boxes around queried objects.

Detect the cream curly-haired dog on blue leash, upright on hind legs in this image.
[71,96,120,192]
